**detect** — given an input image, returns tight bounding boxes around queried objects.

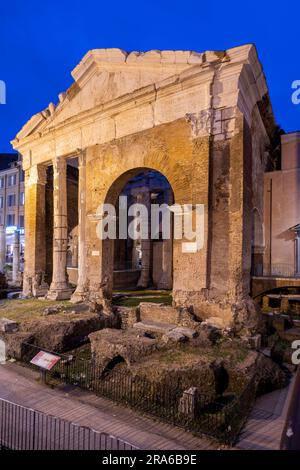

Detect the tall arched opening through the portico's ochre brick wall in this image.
[102,168,175,301]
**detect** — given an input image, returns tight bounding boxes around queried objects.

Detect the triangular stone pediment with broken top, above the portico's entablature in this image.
[17,49,203,139]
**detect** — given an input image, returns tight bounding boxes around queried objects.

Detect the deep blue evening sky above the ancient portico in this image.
[0,0,300,152]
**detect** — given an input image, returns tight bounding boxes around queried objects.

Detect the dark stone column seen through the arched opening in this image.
[136,187,151,288]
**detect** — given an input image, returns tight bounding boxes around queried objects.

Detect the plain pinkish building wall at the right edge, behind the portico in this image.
[264,131,300,278]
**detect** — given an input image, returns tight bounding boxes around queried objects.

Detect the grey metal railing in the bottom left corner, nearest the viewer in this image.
[0,399,138,450]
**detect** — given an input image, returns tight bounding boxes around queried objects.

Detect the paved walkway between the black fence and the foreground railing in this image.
[0,363,218,450]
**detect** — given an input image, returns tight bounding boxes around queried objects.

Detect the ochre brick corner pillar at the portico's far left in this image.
[23,165,48,297]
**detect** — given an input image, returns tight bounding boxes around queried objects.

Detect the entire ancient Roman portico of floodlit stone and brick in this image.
[13,45,274,325]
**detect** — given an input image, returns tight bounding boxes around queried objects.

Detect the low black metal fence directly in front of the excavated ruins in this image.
[23,343,256,444]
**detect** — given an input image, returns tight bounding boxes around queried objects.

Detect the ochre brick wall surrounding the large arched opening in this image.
[86,119,210,308]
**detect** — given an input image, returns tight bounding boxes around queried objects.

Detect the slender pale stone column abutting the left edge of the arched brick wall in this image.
[71,152,86,303]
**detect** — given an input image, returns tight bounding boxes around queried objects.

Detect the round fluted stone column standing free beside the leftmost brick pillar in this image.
[47,157,72,300]
